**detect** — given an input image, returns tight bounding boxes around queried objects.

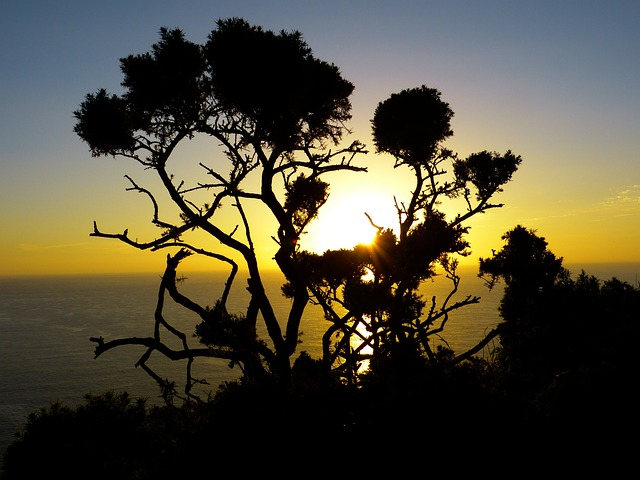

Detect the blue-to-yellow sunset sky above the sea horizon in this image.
[0,0,640,275]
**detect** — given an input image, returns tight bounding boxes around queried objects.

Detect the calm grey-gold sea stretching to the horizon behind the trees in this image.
[0,264,640,452]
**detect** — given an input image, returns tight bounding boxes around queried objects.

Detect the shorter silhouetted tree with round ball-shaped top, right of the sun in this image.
[294,86,521,380]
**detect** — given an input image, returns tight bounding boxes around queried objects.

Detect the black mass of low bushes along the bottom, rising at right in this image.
[2,244,640,480]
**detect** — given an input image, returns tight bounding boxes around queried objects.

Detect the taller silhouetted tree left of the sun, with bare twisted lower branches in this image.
[74,18,365,395]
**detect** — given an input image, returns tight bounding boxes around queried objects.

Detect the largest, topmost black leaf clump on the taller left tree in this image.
[205,18,354,149]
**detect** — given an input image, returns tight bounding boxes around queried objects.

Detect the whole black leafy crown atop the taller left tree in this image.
[74,19,354,155]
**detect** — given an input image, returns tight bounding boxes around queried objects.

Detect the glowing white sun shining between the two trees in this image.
[300,192,398,253]
